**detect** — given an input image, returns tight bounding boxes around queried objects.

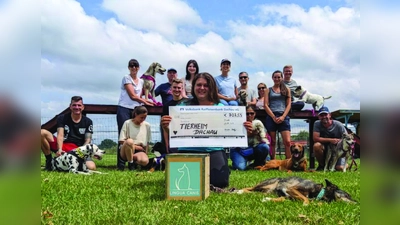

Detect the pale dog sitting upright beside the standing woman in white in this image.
[140,62,166,106]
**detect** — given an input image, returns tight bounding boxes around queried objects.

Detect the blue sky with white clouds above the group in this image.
[40,0,361,142]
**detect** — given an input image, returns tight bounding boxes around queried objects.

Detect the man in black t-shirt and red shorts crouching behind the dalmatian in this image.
[40,96,96,170]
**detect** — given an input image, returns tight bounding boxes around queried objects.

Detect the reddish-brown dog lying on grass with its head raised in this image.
[255,143,307,172]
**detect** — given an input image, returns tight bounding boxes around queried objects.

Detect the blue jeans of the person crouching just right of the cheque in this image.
[230,143,269,170]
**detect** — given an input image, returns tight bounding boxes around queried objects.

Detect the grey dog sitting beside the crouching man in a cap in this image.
[324,133,355,172]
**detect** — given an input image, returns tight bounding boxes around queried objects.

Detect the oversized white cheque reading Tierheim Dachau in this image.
[169,106,247,148]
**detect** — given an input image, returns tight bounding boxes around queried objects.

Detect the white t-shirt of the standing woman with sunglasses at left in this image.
[118,75,143,109]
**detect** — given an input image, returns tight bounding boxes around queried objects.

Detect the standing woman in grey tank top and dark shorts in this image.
[264,70,292,159]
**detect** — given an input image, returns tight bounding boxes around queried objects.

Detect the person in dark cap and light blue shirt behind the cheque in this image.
[215,59,239,106]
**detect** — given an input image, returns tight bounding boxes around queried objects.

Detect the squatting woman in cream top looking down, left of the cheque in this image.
[119,106,151,170]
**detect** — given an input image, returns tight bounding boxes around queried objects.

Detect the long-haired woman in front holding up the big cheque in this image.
[161,73,252,188]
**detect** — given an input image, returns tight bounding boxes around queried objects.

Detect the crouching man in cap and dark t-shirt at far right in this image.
[313,106,347,171]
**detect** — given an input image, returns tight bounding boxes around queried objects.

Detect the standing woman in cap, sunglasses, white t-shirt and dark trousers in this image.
[117,59,154,170]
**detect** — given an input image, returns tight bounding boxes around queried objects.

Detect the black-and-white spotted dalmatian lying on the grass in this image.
[52,144,105,175]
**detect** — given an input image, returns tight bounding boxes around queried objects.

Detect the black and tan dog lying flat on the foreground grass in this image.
[234,177,357,205]
